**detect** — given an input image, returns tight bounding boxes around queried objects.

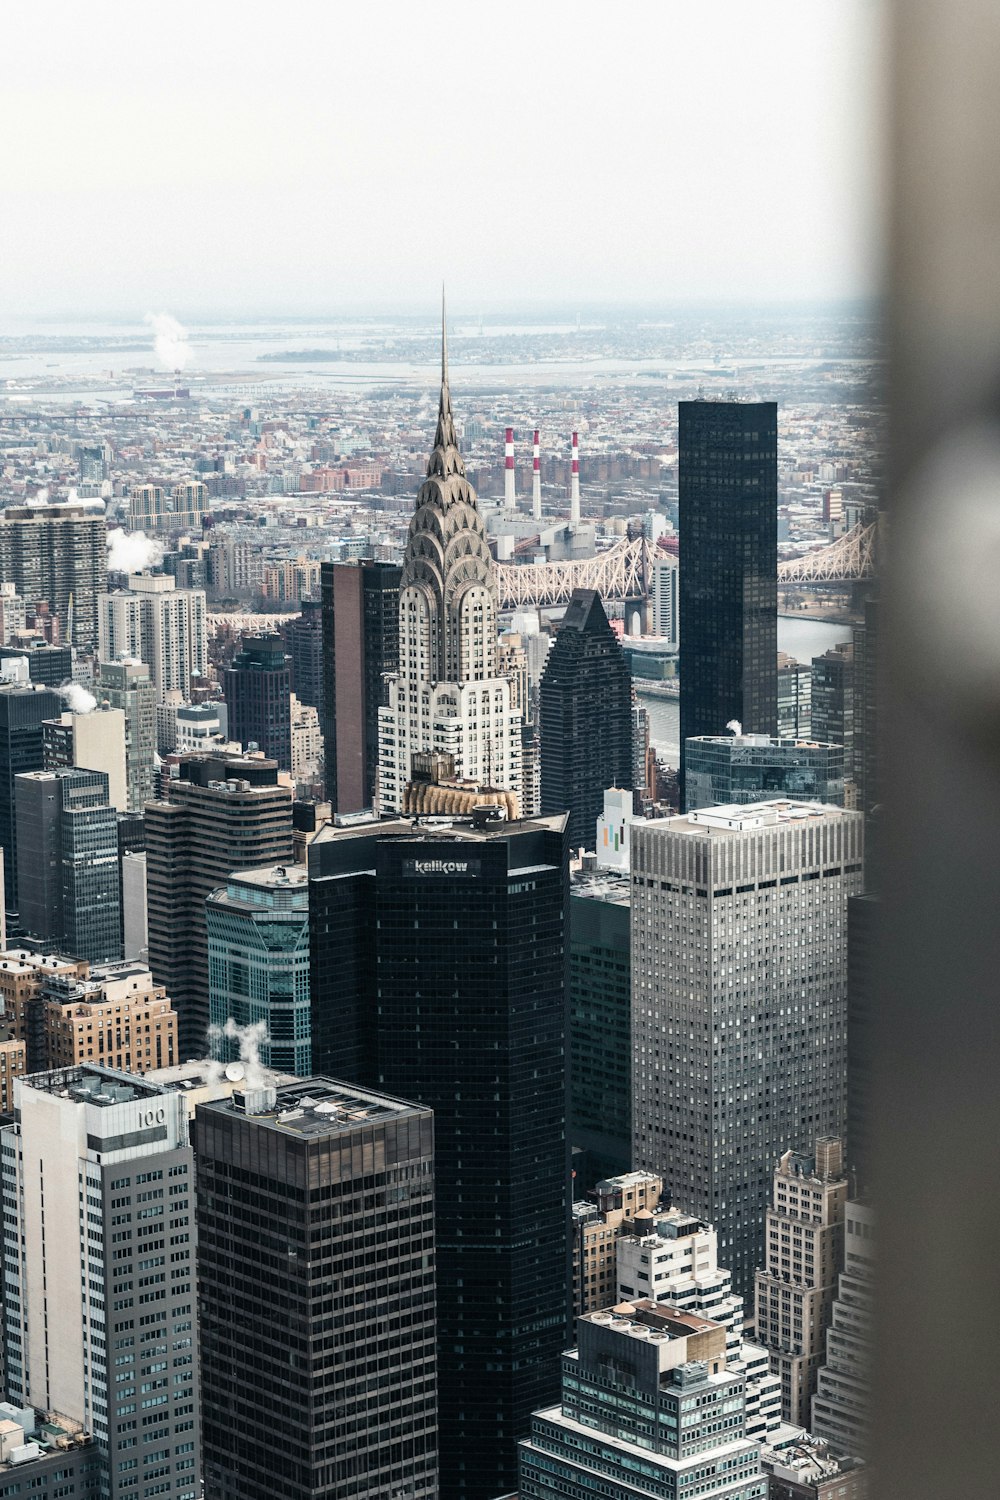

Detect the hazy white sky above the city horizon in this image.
[0,0,879,319]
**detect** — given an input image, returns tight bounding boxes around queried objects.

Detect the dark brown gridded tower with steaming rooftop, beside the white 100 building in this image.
[195,1077,437,1500]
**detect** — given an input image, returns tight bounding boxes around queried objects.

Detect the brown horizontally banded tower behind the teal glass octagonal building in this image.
[145,756,292,1058]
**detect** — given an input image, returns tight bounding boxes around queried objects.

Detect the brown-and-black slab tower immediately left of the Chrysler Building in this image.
[321,561,402,813]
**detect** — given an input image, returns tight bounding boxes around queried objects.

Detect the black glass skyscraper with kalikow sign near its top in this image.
[309,815,570,1500]
